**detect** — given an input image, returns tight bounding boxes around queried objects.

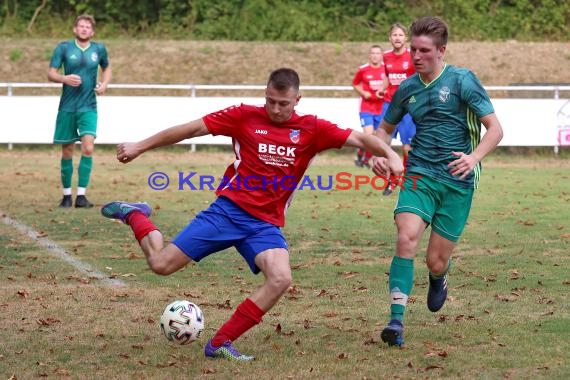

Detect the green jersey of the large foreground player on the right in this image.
[384,64,495,188]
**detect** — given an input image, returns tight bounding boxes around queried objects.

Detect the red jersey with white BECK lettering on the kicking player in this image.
[203,104,351,227]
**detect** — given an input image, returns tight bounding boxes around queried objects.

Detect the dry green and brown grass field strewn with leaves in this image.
[0,147,570,379]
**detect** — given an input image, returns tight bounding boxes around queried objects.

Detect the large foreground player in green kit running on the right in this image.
[373,17,503,346]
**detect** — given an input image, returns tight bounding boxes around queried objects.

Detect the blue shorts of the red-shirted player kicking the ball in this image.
[172,197,289,274]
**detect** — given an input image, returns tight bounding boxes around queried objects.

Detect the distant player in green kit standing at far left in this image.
[48,15,111,207]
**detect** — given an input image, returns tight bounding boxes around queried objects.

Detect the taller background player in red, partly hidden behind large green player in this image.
[381,23,416,195]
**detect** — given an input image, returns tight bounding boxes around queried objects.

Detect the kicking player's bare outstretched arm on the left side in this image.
[117,118,210,164]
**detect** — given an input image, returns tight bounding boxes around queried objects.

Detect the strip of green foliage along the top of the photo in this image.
[0,0,570,41]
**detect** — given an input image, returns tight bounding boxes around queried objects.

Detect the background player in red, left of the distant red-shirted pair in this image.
[352,45,386,167]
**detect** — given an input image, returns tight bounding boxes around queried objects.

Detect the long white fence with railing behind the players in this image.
[0,83,570,151]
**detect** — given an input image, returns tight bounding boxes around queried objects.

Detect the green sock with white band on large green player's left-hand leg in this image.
[389,256,414,322]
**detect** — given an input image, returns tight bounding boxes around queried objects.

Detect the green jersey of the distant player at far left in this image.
[50,40,109,112]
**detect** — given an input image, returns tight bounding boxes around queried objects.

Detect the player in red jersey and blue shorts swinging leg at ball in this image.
[101,68,403,361]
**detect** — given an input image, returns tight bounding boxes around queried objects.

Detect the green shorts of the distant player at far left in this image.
[53,111,97,144]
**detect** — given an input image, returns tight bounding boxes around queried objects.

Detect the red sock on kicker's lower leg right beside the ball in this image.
[211,298,265,347]
